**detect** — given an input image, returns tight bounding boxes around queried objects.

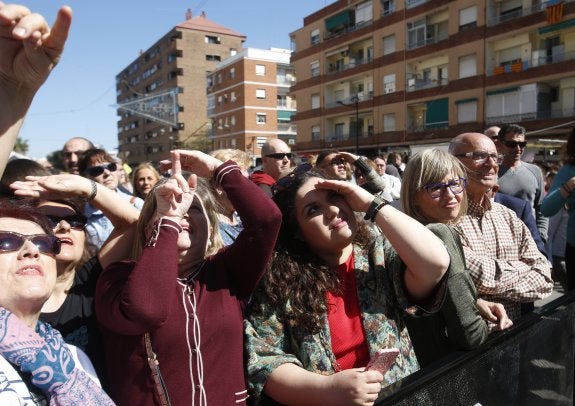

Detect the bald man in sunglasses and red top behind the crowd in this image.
[250,138,293,197]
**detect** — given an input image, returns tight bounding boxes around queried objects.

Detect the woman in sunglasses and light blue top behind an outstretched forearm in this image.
[78,148,144,252]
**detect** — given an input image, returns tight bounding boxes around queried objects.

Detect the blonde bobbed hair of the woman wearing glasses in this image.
[400,149,467,224]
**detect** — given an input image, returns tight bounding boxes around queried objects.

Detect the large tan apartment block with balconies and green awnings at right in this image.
[290,0,575,162]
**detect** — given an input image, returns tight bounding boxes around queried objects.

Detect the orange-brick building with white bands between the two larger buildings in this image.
[207,48,296,157]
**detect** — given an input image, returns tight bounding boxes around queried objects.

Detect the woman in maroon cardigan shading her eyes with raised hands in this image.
[96,150,281,405]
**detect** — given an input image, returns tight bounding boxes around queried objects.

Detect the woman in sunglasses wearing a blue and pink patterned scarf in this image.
[0,198,113,405]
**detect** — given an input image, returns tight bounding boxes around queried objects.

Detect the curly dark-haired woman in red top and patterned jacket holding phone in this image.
[245,165,450,405]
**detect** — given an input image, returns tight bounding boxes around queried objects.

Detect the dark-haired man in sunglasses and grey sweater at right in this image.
[496,124,549,242]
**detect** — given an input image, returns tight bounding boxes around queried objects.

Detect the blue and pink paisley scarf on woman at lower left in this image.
[0,306,114,405]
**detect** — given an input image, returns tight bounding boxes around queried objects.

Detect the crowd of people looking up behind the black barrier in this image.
[0,3,575,405]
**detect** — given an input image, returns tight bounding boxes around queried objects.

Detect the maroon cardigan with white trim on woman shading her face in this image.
[96,162,281,406]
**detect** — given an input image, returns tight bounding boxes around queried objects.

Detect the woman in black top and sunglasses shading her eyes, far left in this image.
[10,174,140,380]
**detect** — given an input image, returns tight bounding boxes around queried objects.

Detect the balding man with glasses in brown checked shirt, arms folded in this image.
[449,133,553,320]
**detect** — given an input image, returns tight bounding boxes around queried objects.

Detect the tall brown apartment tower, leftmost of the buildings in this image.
[116,10,246,165]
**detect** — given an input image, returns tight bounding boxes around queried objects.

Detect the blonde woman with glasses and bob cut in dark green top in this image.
[401,149,512,366]
